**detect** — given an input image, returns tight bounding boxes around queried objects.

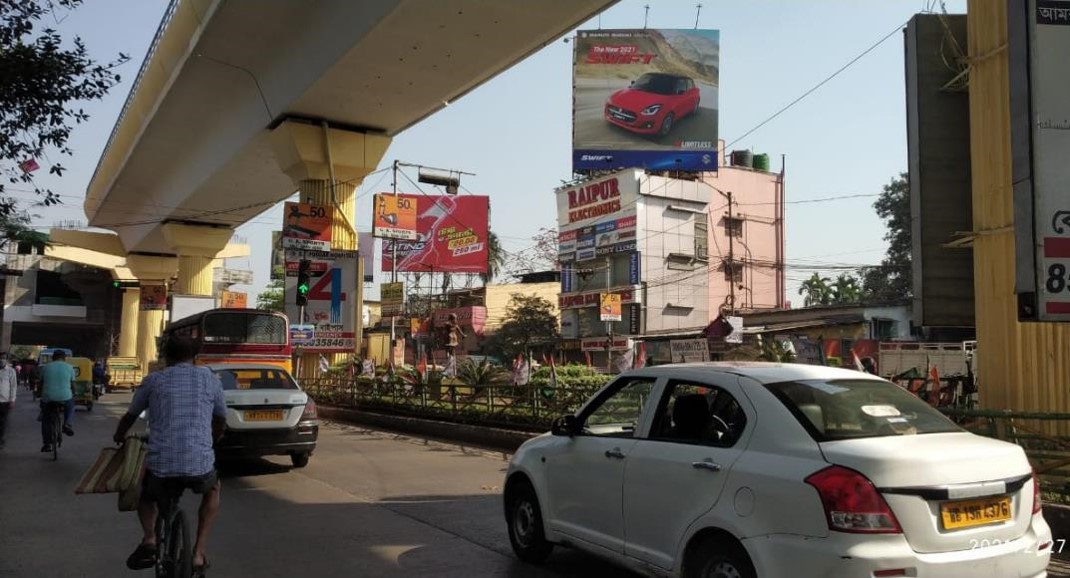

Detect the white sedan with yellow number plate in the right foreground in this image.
[505,364,1052,578]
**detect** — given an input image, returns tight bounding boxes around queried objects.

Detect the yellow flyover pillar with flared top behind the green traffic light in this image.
[272,121,391,378]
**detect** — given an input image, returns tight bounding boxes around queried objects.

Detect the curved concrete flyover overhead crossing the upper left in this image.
[66,0,617,368]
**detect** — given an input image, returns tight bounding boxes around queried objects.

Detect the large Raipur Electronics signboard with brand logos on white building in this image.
[556,170,639,263]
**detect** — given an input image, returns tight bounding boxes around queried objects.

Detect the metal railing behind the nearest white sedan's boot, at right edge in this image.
[941,408,1070,505]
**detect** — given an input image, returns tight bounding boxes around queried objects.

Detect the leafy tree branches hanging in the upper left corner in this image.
[0,0,129,209]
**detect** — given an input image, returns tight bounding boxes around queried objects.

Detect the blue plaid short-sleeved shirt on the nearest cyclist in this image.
[127,363,227,477]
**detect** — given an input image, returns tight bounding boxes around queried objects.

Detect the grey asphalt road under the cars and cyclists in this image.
[0,392,1070,578]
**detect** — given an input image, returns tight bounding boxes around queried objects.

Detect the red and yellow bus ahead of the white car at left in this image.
[162,309,293,371]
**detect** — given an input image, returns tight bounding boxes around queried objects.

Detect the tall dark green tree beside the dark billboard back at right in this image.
[860,172,914,302]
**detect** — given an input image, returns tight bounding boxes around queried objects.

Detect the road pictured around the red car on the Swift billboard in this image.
[574,78,718,150]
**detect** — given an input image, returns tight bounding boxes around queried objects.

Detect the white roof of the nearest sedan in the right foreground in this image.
[625,362,884,384]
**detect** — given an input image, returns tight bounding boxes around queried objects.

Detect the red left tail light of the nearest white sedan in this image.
[806,466,903,534]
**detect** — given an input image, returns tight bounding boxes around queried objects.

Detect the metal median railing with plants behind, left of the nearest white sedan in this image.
[302,377,598,430]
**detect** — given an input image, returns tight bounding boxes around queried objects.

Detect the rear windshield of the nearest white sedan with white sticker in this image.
[766,379,961,441]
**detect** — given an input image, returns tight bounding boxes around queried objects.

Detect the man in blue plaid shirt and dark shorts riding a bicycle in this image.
[114,337,227,576]
